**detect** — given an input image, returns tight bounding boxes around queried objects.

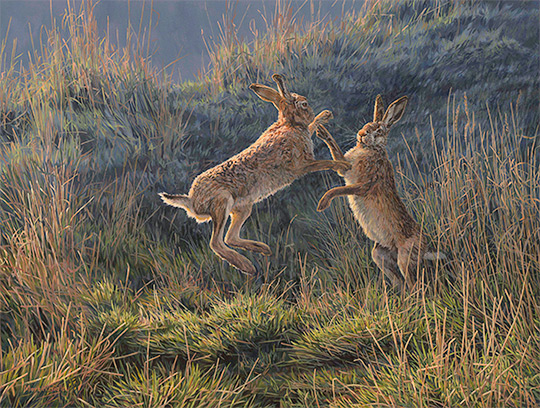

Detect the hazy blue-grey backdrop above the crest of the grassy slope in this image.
[0,0,364,80]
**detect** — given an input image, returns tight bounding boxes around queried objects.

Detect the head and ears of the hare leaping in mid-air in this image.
[250,74,315,127]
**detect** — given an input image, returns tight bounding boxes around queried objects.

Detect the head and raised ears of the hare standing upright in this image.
[357,95,408,147]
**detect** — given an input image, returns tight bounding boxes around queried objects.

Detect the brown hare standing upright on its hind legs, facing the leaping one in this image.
[317,95,438,288]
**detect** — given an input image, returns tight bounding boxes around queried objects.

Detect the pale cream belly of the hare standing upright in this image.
[347,195,395,248]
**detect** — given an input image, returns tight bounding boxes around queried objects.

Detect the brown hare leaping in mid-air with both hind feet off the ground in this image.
[160,74,351,275]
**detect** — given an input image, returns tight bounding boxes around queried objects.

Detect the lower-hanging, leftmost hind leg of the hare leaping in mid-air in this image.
[210,195,256,275]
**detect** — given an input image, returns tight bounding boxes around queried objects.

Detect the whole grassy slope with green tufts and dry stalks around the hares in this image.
[0,1,540,407]
